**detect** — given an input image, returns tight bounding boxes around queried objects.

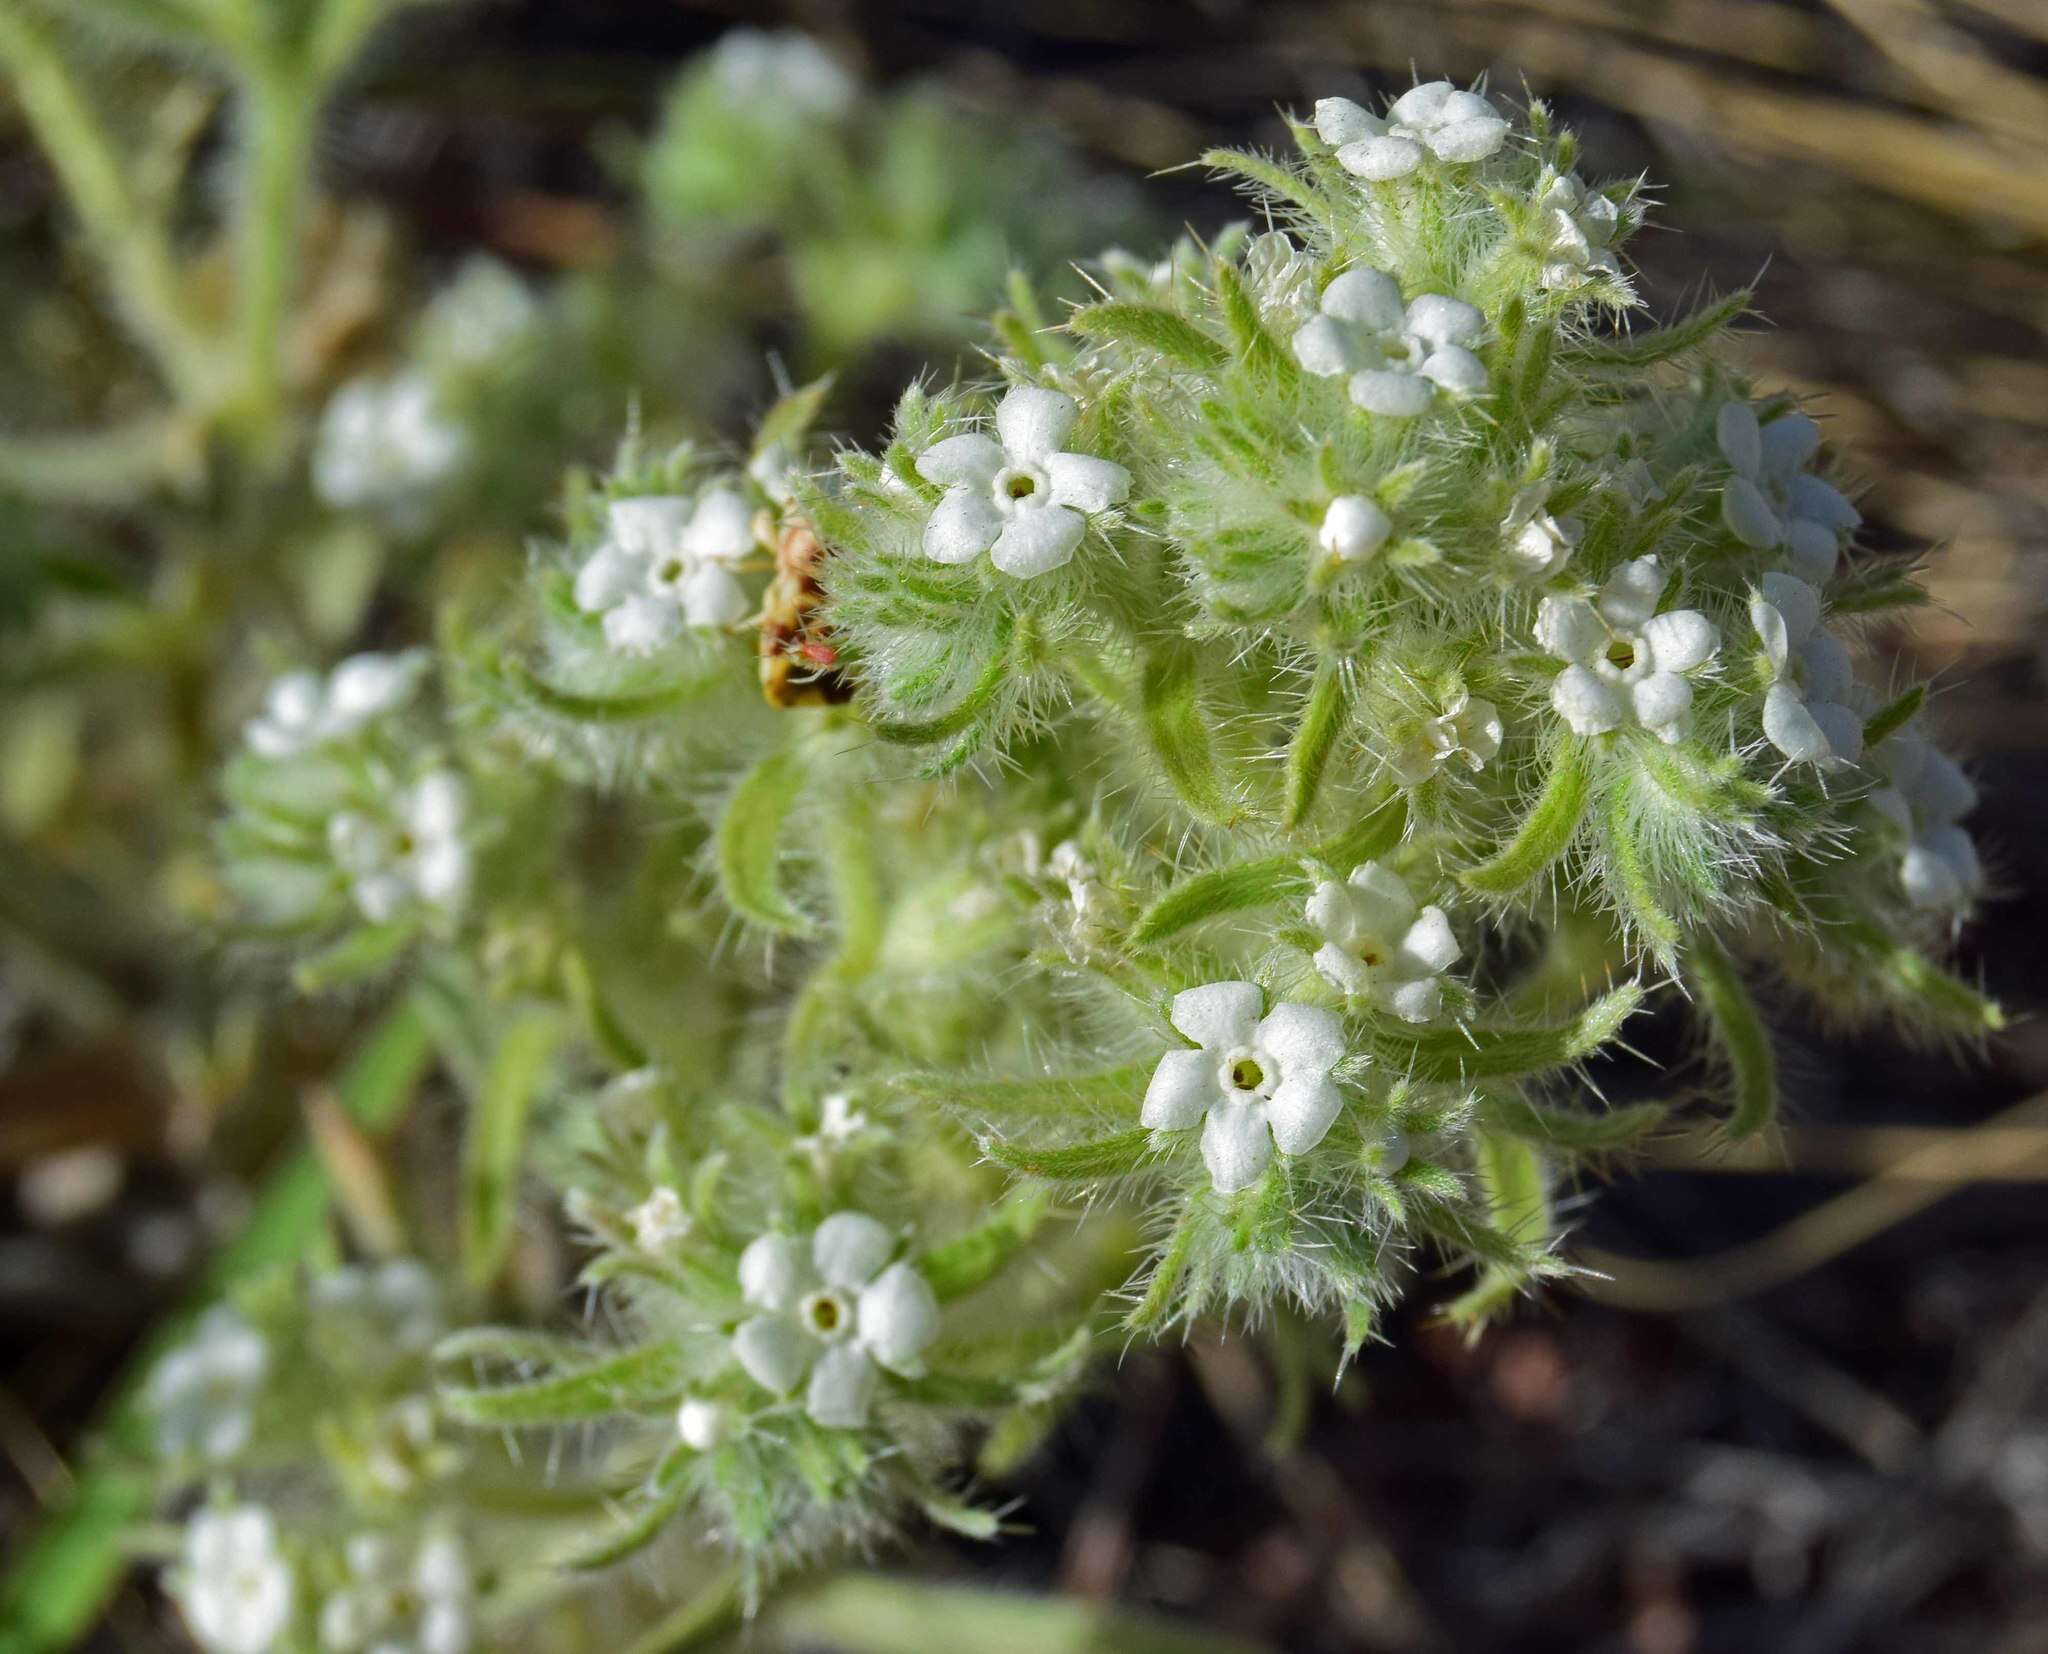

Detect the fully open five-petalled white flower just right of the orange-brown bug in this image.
[918,385,1130,579]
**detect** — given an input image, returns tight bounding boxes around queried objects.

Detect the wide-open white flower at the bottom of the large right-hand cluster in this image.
[1139,983,1346,1195]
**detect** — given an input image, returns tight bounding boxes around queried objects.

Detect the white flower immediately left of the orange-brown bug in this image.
[575,487,754,655]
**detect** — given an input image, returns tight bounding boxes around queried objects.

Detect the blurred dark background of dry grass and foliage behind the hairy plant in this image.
[0,0,2048,1654]
